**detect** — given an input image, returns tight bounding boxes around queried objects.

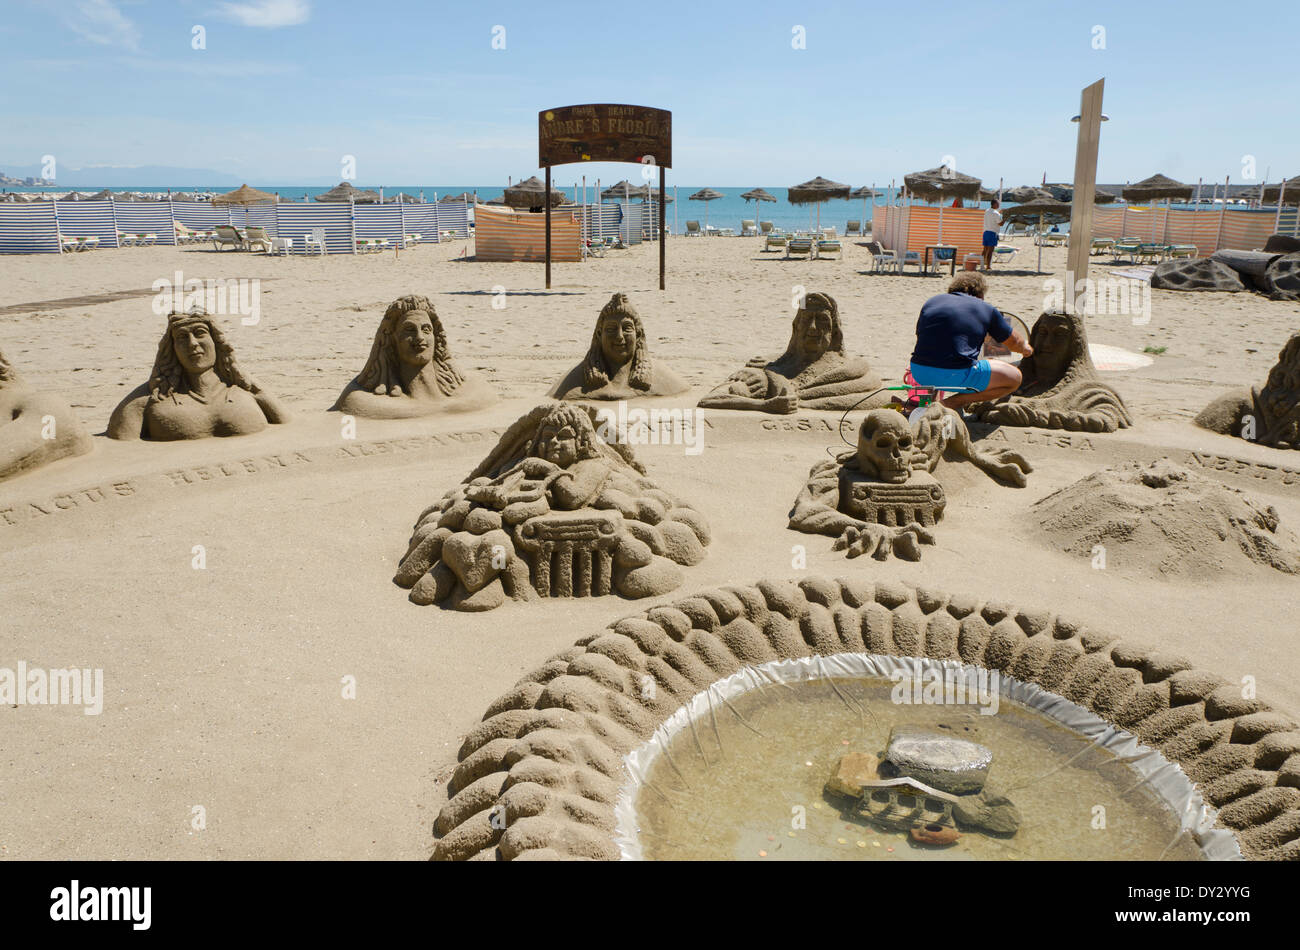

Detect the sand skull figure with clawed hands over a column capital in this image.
[789,403,1034,560]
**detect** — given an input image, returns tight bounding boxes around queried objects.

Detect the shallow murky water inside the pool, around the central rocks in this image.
[636,678,1201,860]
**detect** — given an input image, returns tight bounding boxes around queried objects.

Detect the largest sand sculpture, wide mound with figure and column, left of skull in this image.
[394,403,709,611]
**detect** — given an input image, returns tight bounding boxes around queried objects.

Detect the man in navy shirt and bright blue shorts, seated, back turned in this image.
[911,270,1034,409]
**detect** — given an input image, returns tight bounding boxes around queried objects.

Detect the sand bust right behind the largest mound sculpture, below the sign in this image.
[547,294,690,399]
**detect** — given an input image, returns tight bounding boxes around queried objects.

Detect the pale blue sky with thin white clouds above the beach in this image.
[0,0,1300,187]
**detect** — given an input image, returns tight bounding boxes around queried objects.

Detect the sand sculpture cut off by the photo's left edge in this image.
[0,352,91,480]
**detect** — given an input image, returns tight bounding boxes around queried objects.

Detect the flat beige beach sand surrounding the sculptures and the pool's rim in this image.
[0,238,1300,859]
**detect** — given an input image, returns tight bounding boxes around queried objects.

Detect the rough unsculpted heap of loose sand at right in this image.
[1031,459,1300,577]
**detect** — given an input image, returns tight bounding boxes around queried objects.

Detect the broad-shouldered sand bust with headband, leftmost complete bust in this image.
[108,309,289,442]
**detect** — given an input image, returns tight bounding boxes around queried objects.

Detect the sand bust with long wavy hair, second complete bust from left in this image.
[334,294,497,418]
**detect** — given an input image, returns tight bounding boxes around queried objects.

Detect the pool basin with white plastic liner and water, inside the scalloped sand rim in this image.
[616,654,1240,860]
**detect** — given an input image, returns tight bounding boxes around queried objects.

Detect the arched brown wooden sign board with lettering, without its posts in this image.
[537,103,672,168]
